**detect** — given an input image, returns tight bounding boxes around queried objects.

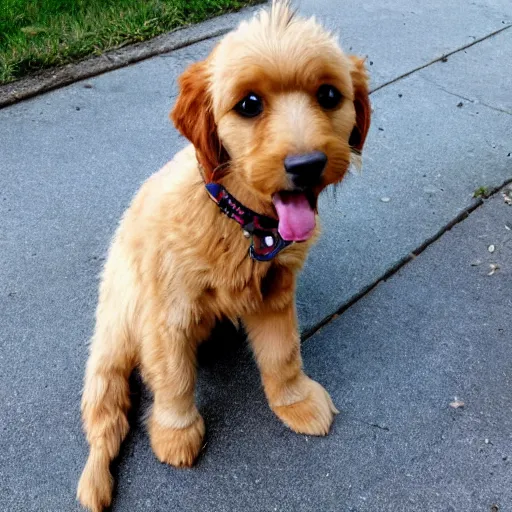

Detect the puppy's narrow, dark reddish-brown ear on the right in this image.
[349,56,371,153]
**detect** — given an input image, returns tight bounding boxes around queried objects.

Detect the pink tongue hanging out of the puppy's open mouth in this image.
[274,192,315,242]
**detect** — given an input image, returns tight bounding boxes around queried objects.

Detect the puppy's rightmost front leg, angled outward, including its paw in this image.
[243,303,338,436]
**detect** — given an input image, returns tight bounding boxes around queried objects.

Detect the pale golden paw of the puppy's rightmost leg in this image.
[272,378,338,436]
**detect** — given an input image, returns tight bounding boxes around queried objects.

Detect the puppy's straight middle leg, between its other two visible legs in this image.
[143,322,210,467]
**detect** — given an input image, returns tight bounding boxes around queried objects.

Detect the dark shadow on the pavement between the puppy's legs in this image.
[111,322,263,503]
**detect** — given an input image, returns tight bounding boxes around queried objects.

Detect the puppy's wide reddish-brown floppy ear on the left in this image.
[170,61,228,181]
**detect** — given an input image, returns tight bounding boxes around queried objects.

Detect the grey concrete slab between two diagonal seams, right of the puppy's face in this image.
[298,31,512,330]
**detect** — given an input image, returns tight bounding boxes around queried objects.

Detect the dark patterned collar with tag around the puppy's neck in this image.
[205,183,292,261]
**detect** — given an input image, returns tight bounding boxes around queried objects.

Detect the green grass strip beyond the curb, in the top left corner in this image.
[0,0,259,84]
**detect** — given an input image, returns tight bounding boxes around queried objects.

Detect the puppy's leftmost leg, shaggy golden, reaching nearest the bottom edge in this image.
[77,264,136,512]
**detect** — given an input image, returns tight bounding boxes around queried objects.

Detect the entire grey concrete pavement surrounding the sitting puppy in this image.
[0,0,512,512]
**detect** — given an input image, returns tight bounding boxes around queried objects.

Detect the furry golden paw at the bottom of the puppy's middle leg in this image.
[149,414,205,467]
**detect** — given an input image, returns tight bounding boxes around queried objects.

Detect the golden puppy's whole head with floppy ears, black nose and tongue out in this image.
[172,0,370,240]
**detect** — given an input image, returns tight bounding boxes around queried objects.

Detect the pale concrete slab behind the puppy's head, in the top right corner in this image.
[299,0,512,88]
